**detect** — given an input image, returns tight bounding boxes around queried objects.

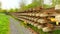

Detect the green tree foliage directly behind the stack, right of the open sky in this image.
[20,0,60,11]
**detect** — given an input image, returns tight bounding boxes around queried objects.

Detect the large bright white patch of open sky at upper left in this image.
[0,0,20,9]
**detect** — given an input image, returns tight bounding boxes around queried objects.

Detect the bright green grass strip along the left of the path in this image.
[0,13,9,34]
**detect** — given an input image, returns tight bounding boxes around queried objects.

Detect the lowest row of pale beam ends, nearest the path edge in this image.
[14,17,52,32]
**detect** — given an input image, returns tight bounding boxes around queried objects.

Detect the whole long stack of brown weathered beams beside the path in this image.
[10,8,60,32]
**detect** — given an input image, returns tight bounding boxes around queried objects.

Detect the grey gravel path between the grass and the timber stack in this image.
[9,17,33,34]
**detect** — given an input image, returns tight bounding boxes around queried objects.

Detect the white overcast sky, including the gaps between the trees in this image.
[0,0,50,9]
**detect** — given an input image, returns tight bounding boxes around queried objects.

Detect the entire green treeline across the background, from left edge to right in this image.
[0,0,60,12]
